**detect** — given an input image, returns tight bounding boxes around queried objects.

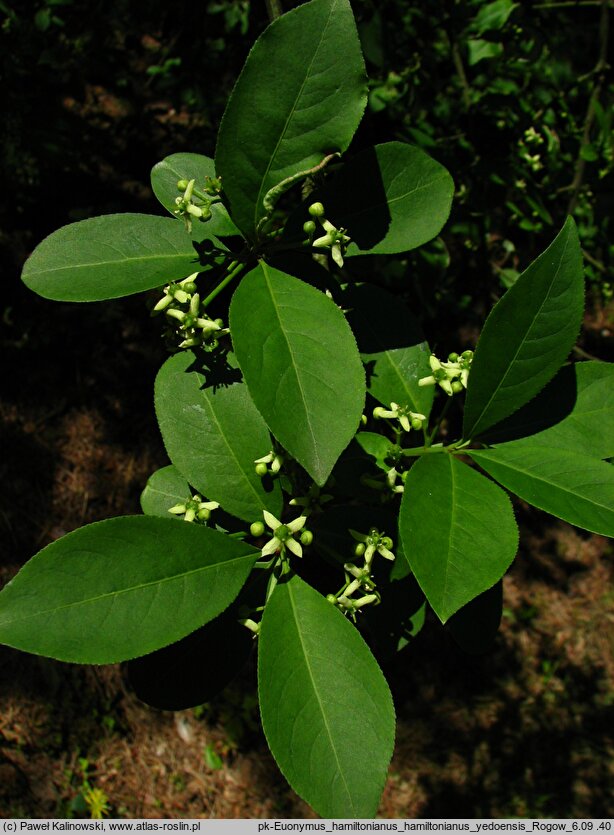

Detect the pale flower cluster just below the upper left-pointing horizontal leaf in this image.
[152,273,228,348]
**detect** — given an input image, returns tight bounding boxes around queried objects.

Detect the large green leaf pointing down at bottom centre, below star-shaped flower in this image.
[258,576,394,818]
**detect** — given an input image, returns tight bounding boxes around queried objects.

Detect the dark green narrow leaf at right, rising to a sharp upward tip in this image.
[463,218,584,439]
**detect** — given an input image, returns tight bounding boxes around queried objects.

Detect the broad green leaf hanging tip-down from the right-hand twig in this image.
[399,453,518,623]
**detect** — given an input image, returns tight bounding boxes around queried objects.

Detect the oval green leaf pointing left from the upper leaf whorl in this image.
[22,214,202,302]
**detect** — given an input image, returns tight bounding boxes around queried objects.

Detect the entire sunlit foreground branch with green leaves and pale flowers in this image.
[0,0,614,817]
